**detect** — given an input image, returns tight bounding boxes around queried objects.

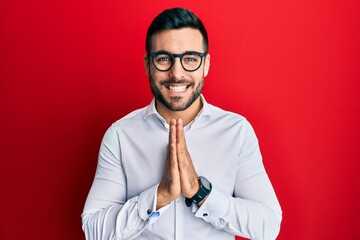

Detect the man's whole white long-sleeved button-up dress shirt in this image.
[82,96,282,240]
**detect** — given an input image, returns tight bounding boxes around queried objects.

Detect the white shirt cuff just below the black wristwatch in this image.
[192,186,230,222]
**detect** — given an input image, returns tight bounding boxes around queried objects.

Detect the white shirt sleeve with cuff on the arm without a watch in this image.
[81,126,168,240]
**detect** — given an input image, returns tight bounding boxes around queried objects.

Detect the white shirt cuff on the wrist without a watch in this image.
[138,185,170,224]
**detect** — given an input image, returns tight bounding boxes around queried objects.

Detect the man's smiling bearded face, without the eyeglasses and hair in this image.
[145,28,210,111]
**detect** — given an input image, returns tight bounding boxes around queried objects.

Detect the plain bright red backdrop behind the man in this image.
[0,0,360,240]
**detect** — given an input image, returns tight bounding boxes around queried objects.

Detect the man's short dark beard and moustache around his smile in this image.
[149,75,204,111]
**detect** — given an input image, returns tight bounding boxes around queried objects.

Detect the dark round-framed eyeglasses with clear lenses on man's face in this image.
[148,50,207,72]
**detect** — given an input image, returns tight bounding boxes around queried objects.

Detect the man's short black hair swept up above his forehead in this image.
[145,8,209,53]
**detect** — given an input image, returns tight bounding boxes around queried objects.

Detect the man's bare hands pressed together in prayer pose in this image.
[156,118,199,209]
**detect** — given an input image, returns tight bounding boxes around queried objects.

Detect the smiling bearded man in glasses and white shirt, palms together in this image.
[82,8,282,240]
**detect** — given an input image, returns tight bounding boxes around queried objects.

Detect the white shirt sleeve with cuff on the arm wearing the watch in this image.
[193,122,282,240]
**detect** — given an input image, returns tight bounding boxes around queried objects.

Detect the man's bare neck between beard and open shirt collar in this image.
[155,97,203,126]
